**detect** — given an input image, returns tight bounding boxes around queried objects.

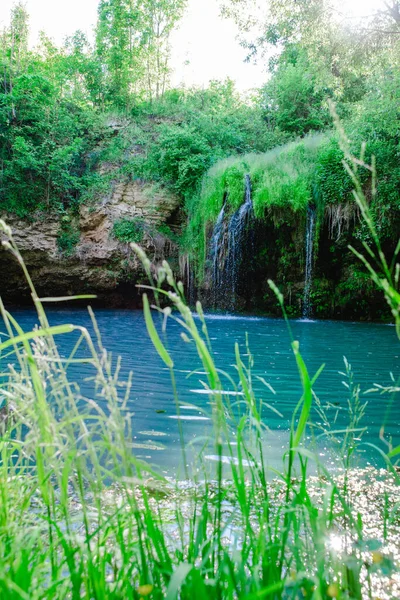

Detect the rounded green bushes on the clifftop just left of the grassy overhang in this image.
[120,80,285,198]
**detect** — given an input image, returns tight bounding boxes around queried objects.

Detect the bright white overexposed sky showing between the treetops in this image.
[0,0,388,90]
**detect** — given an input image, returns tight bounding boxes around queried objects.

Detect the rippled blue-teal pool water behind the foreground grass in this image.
[0,309,400,469]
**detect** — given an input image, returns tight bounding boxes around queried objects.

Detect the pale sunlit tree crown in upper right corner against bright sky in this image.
[223,0,400,121]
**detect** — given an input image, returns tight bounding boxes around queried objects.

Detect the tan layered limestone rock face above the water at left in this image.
[0,181,179,306]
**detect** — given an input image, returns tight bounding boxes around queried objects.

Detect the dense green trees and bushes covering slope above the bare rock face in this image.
[0,0,280,215]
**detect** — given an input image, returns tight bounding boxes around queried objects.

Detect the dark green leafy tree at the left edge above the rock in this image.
[0,5,101,214]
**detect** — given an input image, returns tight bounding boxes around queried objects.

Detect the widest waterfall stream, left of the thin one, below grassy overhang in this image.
[211,175,254,310]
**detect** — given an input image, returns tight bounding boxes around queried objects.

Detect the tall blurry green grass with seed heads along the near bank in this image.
[0,140,400,600]
